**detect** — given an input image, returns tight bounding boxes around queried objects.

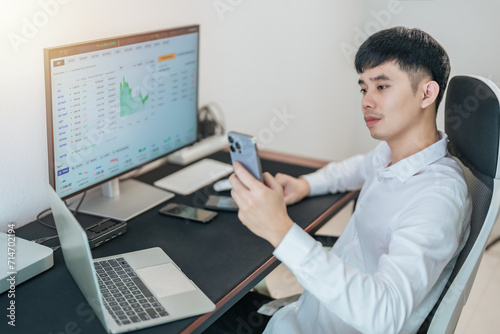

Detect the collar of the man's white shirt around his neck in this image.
[373,131,448,182]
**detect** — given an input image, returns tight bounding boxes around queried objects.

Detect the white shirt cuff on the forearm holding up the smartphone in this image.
[273,224,316,269]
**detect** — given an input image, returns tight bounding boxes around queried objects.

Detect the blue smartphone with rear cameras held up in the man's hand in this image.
[227,131,262,182]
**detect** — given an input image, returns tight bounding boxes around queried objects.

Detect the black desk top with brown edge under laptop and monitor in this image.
[0,152,356,334]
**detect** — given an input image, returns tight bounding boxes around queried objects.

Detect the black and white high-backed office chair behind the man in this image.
[418,76,500,334]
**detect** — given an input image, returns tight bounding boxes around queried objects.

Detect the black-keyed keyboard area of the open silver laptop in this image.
[94,257,168,325]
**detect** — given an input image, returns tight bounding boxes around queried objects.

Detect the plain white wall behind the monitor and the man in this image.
[0,0,500,231]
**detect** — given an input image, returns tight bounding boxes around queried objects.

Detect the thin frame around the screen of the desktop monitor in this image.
[44,24,200,200]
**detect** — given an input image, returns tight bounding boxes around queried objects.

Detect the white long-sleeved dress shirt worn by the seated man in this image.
[265,132,472,334]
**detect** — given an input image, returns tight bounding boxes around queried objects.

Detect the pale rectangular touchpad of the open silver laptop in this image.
[136,263,195,298]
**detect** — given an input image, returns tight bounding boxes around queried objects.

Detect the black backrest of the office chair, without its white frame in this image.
[418,76,500,333]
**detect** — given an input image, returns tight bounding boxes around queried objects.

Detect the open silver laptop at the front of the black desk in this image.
[47,184,215,333]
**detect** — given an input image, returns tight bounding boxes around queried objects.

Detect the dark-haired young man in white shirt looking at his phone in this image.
[230,27,471,334]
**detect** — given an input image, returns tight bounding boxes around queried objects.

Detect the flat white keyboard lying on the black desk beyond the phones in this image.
[154,159,233,195]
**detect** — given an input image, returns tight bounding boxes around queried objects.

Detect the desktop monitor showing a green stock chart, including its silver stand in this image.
[44,25,200,220]
